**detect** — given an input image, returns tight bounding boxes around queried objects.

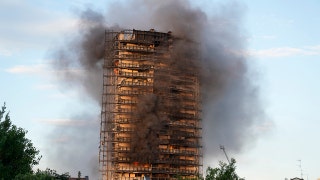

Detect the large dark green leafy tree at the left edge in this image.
[0,104,41,180]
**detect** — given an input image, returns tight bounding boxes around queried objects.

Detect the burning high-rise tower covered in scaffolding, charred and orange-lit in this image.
[99,29,202,180]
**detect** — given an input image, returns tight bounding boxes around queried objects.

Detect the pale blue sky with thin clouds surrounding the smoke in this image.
[0,0,320,180]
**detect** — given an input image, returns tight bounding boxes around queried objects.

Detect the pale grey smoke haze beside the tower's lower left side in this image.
[44,112,100,179]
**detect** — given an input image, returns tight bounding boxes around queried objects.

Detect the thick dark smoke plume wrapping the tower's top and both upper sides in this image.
[51,0,264,175]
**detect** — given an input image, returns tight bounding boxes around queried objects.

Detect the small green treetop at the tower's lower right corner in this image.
[206,158,244,180]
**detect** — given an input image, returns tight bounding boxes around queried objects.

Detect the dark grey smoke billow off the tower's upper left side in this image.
[54,10,106,102]
